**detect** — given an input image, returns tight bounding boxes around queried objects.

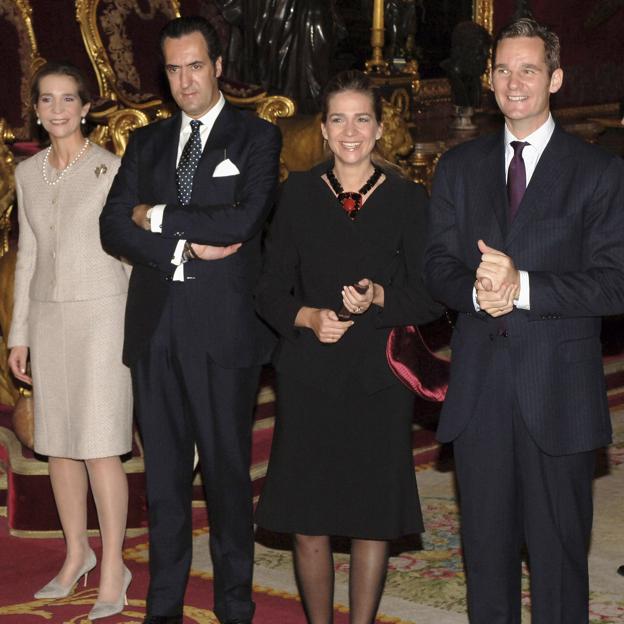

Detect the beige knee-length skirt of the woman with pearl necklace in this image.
[28,295,132,459]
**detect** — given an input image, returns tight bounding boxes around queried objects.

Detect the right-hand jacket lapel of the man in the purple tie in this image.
[505,126,568,245]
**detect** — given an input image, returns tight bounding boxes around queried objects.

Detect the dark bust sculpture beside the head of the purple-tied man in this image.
[440,21,492,108]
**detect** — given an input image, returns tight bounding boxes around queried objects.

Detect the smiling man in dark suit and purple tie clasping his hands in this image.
[425,19,624,624]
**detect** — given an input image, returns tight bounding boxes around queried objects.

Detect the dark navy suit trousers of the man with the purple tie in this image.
[454,337,595,624]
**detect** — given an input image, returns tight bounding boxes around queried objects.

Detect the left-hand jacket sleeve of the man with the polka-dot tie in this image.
[100,130,178,274]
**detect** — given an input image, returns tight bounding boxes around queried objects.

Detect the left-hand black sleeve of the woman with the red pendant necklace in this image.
[256,174,304,338]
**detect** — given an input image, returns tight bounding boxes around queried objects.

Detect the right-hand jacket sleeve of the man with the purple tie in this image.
[519,157,624,318]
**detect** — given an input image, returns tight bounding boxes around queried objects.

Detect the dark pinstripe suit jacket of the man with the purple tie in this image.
[425,127,624,455]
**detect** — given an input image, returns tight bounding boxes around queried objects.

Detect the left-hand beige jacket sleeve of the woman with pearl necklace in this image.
[7,173,37,348]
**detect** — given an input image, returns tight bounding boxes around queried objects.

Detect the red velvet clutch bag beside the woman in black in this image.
[386,325,451,402]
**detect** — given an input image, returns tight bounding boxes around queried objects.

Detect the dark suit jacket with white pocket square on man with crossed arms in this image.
[100,104,281,368]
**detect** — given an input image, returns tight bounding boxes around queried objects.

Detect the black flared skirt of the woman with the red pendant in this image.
[256,374,423,539]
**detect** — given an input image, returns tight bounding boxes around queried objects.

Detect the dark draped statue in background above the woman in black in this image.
[212,0,341,112]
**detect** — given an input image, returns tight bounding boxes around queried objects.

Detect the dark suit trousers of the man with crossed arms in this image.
[132,283,260,622]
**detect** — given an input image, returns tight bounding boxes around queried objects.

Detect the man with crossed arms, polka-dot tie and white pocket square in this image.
[100,17,281,623]
